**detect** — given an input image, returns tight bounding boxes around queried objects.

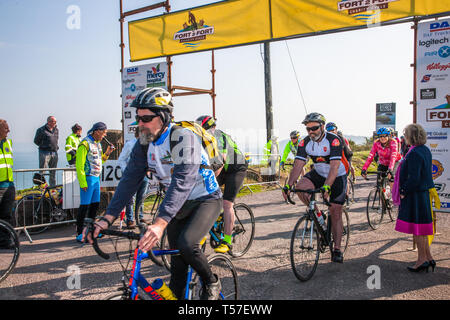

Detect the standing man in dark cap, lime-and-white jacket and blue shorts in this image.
[75,122,114,242]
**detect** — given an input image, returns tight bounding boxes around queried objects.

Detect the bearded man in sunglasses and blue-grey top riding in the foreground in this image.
[82,88,222,300]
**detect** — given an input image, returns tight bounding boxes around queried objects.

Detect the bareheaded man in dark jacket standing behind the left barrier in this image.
[34,116,59,186]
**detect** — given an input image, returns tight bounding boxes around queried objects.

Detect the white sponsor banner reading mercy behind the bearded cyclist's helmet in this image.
[122,62,168,142]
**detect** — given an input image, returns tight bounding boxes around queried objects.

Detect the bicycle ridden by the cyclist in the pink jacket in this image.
[366,171,398,230]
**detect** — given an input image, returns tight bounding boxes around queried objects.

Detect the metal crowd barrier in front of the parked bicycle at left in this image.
[11,167,80,242]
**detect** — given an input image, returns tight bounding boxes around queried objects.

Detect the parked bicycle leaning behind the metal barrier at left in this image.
[13,174,68,234]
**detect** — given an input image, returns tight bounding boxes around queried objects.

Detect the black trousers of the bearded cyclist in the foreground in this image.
[167,199,223,299]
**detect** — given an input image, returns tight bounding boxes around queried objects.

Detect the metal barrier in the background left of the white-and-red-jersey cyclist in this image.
[241,153,281,193]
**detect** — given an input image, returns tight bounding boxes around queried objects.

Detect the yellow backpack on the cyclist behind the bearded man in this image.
[170,121,223,171]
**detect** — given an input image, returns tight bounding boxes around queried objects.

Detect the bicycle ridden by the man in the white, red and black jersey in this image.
[286,188,350,281]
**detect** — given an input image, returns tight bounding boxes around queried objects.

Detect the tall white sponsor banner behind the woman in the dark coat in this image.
[416,18,450,212]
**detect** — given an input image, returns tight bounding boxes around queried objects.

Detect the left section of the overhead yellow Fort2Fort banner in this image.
[128,0,270,61]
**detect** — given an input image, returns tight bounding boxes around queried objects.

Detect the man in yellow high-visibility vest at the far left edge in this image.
[0,119,16,223]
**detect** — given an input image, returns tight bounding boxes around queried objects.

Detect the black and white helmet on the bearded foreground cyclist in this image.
[130,88,173,113]
